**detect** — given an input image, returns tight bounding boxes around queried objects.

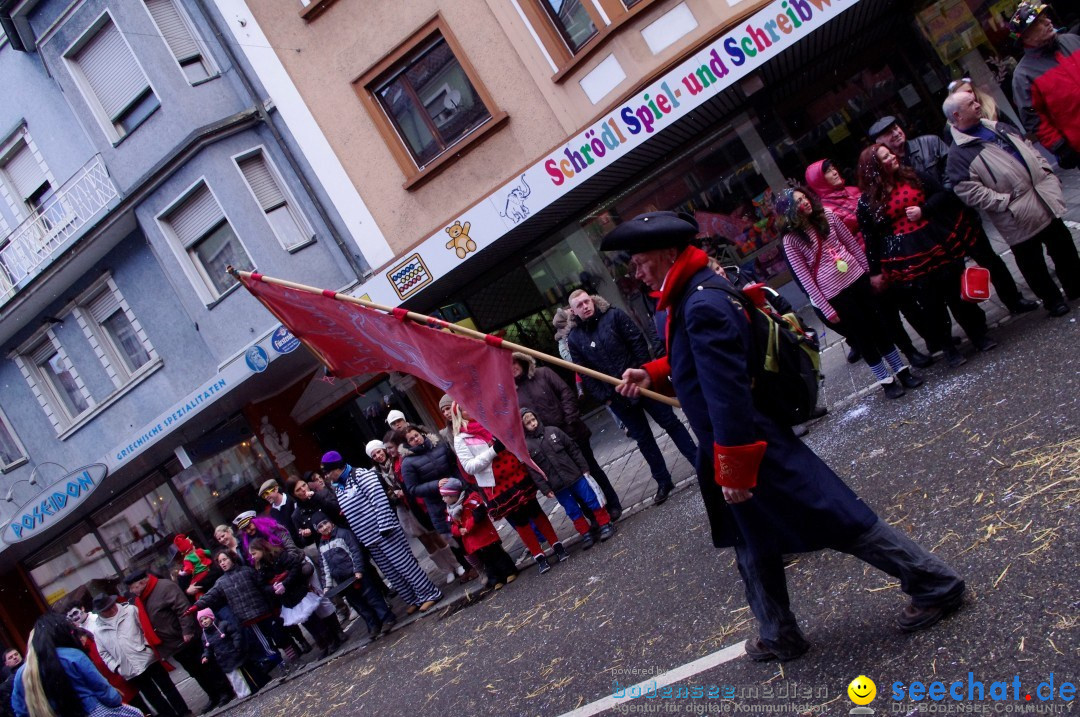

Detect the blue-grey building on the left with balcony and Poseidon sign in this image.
[0,0,447,646]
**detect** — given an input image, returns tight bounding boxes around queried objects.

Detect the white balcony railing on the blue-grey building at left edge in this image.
[0,155,119,305]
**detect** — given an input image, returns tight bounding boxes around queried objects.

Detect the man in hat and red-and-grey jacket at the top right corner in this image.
[1009,0,1080,170]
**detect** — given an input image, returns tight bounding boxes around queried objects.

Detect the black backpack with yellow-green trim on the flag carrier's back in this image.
[682,278,821,425]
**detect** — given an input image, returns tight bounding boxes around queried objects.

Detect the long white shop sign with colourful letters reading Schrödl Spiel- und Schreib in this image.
[354,0,859,306]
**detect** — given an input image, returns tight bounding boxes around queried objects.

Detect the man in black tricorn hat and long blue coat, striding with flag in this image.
[600,212,964,661]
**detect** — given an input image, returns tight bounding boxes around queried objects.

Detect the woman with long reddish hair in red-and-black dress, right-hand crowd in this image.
[856,145,997,367]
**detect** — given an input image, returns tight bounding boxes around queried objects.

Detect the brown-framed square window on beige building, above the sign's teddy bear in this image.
[353,17,505,188]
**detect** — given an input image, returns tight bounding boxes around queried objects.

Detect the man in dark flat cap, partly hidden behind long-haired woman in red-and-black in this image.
[867,116,1039,315]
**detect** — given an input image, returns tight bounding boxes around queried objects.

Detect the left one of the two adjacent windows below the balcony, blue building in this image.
[15,328,94,433]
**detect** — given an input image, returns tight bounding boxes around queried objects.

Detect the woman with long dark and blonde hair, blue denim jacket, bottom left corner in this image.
[11,612,143,717]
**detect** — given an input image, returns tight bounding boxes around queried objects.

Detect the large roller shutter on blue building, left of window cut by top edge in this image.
[75,23,149,121]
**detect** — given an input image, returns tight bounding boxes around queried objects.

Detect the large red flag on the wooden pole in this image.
[240,276,539,470]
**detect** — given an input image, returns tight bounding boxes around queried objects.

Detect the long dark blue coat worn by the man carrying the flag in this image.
[667,268,877,553]
